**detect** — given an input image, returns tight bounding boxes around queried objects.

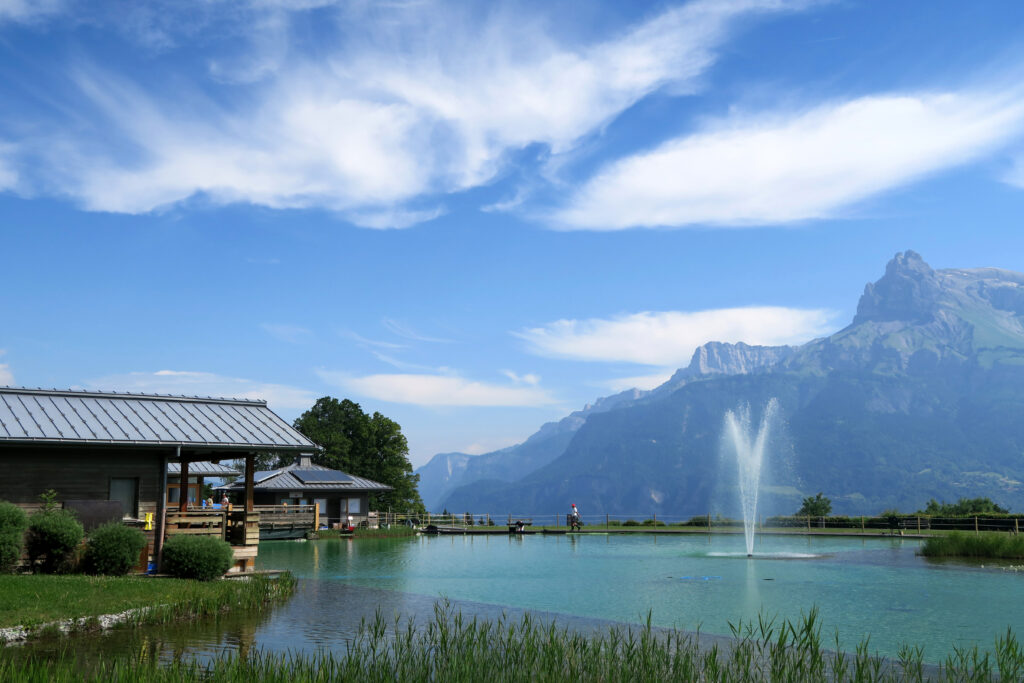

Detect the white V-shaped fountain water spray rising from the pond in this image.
[724,398,778,557]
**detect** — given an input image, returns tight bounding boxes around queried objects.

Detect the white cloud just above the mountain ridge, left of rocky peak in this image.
[516,306,833,368]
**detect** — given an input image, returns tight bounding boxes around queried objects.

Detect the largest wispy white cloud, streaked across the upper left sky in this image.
[14,0,799,219]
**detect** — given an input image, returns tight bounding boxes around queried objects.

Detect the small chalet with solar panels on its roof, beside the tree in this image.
[218,454,391,526]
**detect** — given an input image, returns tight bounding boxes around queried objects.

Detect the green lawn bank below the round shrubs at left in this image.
[0,574,295,634]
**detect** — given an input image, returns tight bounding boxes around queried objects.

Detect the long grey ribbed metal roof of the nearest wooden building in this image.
[0,387,315,451]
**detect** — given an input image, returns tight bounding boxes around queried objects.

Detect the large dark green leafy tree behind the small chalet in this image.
[294,396,424,512]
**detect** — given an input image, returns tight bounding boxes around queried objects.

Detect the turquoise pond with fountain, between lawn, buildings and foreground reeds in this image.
[8,533,1024,661]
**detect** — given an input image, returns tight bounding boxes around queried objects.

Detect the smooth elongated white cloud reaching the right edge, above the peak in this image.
[555,88,1024,229]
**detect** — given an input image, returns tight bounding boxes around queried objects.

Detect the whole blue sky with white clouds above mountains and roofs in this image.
[0,0,1024,465]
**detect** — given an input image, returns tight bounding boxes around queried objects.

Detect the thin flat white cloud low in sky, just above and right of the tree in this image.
[317,371,556,408]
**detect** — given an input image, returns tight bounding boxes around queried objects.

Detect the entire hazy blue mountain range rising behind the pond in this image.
[444,251,1024,516]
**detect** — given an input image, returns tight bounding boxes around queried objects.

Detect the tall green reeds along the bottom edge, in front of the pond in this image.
[0,606,1024,683]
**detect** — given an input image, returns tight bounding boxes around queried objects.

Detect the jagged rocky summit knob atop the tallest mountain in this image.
[853,250,942,325]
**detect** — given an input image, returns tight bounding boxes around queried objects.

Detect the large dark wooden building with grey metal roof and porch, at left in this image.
[0,388,315,570]
